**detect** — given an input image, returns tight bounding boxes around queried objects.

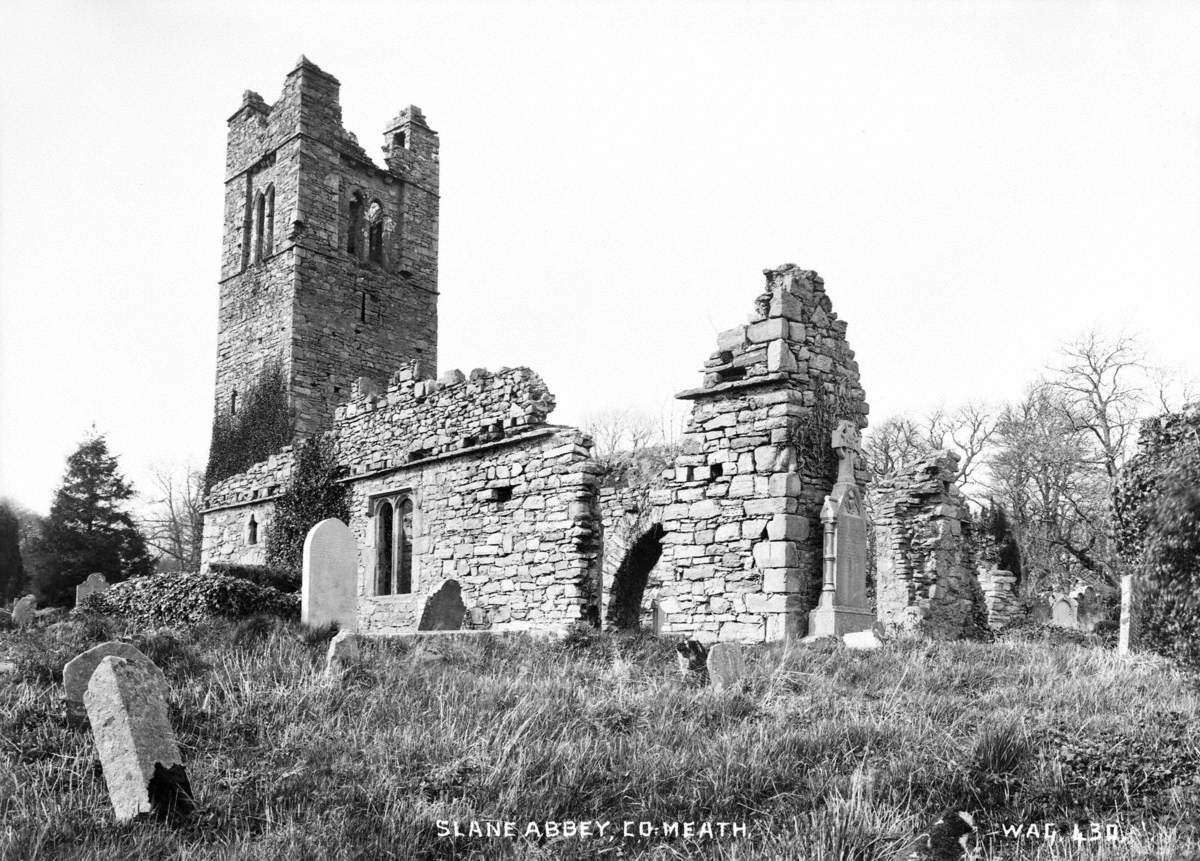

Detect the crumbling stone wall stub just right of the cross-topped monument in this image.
[875,451,986,639]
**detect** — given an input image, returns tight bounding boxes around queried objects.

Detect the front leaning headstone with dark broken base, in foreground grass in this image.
[84,655,194,823]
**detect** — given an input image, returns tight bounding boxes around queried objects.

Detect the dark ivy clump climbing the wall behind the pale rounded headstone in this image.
[266,436,350,584]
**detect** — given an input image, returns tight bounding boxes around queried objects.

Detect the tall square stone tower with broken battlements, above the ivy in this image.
[215,56,438,439]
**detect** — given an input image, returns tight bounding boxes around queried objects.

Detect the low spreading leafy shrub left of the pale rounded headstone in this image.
[88,572,300,628]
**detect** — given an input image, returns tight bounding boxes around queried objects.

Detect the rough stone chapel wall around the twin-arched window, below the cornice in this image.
[350,428,600,633]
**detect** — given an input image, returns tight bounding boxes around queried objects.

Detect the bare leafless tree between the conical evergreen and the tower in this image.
[140,464,204,571]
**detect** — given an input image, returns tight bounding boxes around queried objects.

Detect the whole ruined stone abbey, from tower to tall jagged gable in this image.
[204,58,1012,642]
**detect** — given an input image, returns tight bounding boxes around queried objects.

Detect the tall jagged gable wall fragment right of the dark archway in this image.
[652,265,868,642]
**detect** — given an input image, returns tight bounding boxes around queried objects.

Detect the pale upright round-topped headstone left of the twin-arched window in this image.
[300,517,359,631]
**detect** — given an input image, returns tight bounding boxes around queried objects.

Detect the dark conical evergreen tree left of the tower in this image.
[34,433,154,606]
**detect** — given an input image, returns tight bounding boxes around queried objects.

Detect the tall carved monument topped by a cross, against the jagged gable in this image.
[809,421,875,638]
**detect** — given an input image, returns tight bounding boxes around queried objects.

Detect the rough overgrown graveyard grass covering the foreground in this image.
[0,618,1200,861]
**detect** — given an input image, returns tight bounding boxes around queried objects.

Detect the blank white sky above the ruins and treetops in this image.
[0,0,1200,511]
